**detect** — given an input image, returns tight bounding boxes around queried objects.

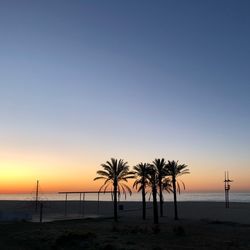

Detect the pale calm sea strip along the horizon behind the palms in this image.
[0,192,250,202]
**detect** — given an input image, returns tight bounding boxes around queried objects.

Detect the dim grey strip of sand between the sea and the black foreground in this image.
[0,201,250,224]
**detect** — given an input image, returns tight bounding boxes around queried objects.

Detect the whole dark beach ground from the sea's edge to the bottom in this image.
[0,201,250,250]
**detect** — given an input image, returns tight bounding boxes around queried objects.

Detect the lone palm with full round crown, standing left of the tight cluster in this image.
[94,158,134,221]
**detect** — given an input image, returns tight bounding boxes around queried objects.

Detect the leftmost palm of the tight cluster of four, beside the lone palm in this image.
[133,162,150,220]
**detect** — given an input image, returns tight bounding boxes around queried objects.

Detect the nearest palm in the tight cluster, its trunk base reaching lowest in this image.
[147,165,158,224]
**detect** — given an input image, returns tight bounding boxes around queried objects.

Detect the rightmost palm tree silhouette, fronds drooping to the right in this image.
[166,161,190,220]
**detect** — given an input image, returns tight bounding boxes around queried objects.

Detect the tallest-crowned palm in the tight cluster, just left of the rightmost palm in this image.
[153,158,166,217]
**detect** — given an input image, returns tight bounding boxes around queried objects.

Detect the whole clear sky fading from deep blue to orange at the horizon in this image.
[0,0,250,193]
